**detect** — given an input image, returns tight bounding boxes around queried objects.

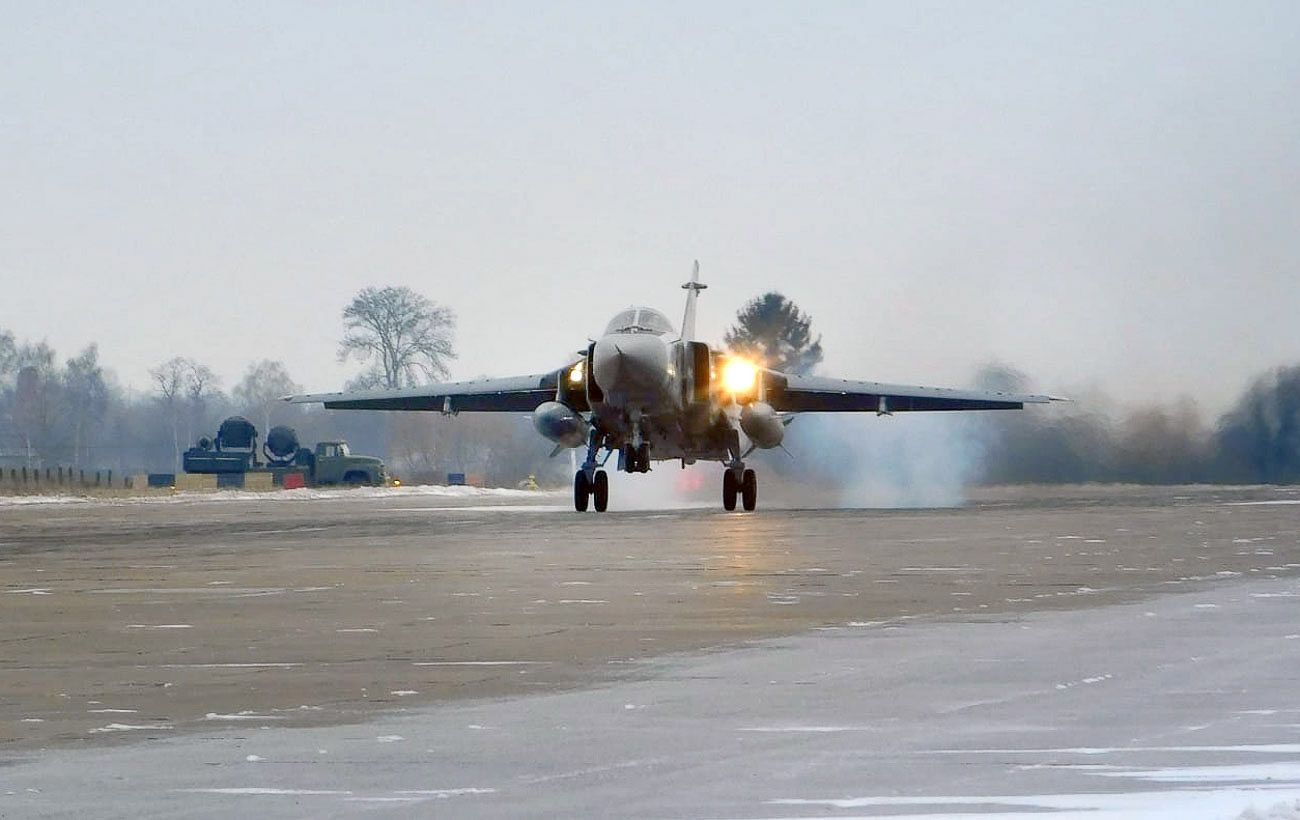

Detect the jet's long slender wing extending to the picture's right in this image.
[766,370,1062,413]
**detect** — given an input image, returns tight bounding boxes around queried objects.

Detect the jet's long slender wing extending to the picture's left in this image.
[285,370,559,413]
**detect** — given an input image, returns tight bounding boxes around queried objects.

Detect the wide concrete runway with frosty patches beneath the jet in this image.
[0,487,1300,819]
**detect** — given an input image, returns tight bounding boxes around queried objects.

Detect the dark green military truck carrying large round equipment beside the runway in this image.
[182,416,389,487]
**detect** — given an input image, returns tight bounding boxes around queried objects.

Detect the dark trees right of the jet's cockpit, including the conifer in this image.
[725,292,1300,485]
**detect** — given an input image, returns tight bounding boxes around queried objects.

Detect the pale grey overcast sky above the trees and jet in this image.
[0,3,1300,409]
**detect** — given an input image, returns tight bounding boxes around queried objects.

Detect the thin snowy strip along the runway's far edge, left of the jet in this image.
[0,485,566,507]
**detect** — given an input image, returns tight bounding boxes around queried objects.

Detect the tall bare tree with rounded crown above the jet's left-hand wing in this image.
[338,287,456,389]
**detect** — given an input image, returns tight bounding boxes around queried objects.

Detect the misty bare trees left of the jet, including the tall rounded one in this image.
[0,287,568,486]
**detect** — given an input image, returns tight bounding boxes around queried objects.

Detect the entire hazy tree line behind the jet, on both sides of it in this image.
[0,287,1300,486]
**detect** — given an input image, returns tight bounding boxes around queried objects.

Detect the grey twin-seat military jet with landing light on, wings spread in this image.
[286,261,1056,512]
